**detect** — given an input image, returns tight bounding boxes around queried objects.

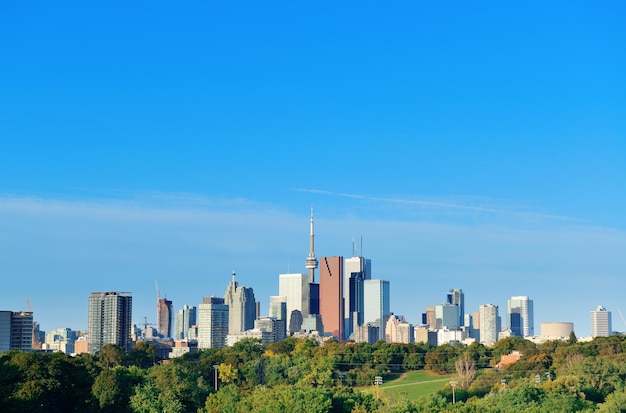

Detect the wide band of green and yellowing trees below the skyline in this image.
[0,336,626,413]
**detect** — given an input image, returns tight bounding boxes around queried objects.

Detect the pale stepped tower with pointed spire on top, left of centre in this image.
[224,271,256,334]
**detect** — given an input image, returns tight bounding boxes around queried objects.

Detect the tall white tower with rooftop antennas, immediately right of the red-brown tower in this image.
[343,249,372,339]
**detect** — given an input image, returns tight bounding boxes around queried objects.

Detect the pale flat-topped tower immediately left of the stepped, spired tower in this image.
[198,297,228,349]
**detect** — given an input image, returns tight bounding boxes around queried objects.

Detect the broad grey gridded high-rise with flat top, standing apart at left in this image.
[88,291,133,354]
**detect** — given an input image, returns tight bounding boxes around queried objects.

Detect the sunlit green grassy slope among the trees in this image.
[371,370,452,400]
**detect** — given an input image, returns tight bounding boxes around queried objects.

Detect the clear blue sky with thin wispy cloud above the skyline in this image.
[0,1,626,335]
